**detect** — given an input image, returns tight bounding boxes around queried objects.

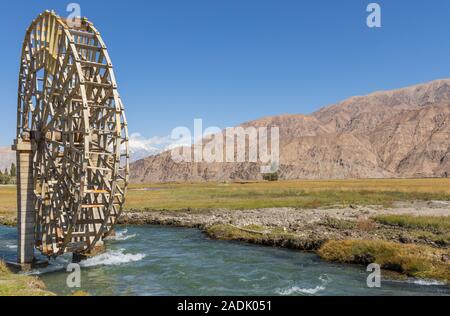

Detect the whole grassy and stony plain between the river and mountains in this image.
[0,179,450,292]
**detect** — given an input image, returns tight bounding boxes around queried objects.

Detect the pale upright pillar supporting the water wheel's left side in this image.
[13,139,35,264]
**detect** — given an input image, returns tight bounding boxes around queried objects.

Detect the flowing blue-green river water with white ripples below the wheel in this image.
[0,226,450,295]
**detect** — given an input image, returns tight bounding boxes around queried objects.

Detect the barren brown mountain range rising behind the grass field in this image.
[131,79,450,182]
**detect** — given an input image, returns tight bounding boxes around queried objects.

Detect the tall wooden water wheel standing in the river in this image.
[17,11,129,257]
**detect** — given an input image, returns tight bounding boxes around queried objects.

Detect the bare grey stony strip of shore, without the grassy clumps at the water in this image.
[119,201,450,250]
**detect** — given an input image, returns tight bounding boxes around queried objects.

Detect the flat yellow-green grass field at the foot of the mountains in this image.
[0,179,450,218]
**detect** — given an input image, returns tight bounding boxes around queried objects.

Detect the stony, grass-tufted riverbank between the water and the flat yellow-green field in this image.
[120,201,450,283]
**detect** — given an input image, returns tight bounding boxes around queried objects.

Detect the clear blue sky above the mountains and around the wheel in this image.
[0,0,450,145]
